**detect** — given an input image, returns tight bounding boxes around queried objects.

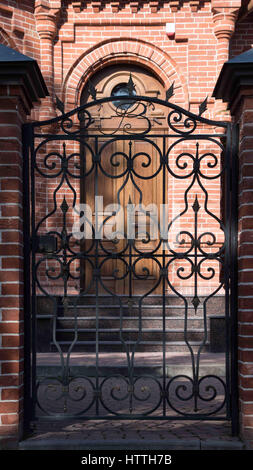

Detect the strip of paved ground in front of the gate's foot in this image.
[18,421,245,450]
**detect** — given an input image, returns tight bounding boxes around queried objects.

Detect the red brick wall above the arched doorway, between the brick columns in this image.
[58,2,217,114]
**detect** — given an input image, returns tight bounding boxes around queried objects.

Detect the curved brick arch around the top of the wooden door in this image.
[62,38,189,111]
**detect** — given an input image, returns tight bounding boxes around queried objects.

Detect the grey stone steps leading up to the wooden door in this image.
[36,295,223,352]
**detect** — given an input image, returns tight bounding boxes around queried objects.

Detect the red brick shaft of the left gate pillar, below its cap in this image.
[0,86,26,444]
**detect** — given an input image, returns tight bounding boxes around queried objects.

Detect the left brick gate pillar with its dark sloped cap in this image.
[0,45,47,444]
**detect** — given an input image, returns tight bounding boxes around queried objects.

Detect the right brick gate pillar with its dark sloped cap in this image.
[214,49,253,447]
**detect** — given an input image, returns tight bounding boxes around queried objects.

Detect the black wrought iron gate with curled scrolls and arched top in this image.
[24,86,237,428]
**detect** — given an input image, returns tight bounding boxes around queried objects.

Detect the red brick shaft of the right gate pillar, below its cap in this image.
[233,98,253,444]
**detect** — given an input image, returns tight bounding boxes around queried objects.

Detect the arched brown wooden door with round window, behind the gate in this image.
[81,64,166,297]
